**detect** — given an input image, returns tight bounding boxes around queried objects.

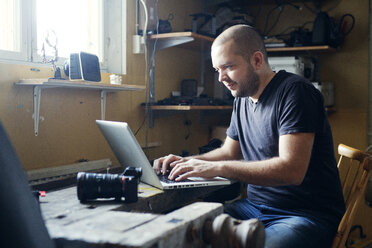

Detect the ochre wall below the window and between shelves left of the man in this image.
[0,0,224,170]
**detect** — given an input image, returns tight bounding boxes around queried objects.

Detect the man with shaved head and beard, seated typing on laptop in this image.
[154,25,345,248]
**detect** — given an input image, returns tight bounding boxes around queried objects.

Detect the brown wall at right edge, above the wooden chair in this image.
[321,0,369,150]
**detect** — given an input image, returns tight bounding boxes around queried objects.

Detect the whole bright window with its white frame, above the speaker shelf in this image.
[0,0,126,74]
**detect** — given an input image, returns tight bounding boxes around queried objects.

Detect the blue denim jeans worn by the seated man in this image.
[224,199,337,248]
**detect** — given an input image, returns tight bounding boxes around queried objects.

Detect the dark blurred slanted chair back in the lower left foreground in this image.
[0,122,55,248]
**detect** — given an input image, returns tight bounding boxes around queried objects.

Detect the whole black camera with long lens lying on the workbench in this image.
[76,167,142,203]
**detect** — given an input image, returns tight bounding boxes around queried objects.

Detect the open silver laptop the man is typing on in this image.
[96,120,231,190]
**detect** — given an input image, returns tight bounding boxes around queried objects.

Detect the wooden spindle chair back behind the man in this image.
[332,144,372,248]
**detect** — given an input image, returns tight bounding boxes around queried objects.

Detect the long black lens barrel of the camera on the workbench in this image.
[77,172,125,201]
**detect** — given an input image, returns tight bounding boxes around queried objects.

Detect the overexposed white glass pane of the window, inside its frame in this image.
[36,0,103,59]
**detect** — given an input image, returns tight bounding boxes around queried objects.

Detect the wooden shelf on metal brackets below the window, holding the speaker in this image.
[14,78,145,136]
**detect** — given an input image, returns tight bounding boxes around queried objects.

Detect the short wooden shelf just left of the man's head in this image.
[150,32,214,50]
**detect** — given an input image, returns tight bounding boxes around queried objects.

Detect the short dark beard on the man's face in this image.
[231,66,259,97]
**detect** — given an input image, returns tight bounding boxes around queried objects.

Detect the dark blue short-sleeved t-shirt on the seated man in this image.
[227,71,345,225]
